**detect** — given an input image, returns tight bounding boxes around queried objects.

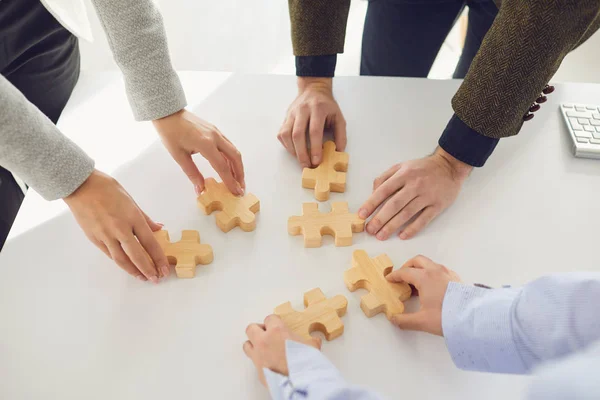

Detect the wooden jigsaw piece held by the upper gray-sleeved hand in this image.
[198,178,260,232]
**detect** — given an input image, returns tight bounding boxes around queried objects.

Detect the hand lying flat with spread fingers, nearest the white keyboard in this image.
[358,147,473,240]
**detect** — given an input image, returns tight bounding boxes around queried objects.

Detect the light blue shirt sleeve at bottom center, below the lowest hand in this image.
[264,340,383,400]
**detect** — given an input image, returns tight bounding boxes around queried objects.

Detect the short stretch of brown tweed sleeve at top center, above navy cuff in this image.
[288,0,350,56]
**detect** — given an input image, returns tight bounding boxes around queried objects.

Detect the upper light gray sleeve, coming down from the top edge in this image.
[92,0,186,120]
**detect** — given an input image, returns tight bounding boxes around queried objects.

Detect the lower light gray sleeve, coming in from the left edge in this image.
[0,75,94,200]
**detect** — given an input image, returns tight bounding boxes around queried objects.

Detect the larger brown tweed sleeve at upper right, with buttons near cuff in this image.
[452,0,600,138]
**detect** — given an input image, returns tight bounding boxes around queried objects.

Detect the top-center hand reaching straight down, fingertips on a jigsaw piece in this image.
[277,77,346,167]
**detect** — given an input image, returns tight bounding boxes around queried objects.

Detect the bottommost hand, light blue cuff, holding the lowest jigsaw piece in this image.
[244,315,321,386]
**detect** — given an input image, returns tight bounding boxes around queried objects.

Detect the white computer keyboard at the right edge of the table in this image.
[560,103,600,158]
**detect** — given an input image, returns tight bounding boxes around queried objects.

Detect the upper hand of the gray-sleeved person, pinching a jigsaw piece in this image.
[152,109,246,196]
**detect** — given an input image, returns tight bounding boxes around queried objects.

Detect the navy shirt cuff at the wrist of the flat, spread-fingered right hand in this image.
[438,114,499,167]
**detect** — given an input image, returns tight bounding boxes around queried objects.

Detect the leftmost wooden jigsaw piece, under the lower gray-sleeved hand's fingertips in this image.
[154,230,213,278]
